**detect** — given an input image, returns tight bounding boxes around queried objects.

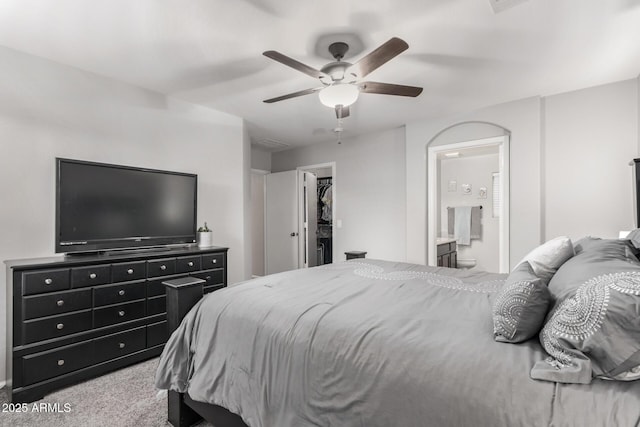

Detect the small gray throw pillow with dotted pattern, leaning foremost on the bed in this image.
[493,261,551,343]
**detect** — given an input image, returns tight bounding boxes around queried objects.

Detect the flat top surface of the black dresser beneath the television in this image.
[4,246,229,269]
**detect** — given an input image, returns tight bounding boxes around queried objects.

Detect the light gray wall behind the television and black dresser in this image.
[0,48,251,381]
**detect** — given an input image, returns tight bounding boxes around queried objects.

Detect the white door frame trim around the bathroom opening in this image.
[427,135,510,273]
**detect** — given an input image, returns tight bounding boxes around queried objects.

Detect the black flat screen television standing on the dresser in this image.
[55,158,198,253]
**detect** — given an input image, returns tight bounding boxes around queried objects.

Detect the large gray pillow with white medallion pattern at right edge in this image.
[531,239,640,384]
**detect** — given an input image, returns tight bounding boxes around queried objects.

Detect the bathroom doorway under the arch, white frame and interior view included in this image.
[428,136,509,272]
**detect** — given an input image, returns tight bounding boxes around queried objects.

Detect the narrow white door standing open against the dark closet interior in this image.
[298,171,318,268]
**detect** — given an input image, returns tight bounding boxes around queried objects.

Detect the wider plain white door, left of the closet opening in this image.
[265,171,298,274]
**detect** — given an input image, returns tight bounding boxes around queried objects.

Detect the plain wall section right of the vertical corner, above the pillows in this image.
[542,80,638,239]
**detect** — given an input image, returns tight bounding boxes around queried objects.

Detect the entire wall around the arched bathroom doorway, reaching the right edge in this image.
[406,79,640,266]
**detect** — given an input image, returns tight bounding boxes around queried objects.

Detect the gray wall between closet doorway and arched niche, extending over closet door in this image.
[272,128,406,261]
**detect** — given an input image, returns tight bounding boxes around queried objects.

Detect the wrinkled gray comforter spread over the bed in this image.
[156,260,640,427]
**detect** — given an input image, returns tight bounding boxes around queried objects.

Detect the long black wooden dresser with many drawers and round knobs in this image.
[6,247,228,402]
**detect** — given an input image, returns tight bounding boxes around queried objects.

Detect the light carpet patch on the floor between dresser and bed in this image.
[0,358,210,427]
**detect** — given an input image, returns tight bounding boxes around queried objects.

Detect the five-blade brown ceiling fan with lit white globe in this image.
[263,37,422,119]
